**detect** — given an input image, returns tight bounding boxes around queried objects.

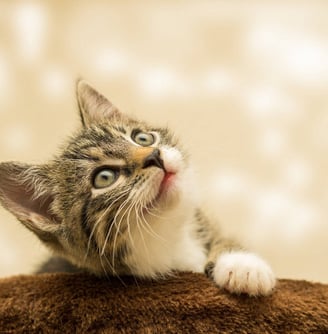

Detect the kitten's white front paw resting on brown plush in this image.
[213,251,276,296]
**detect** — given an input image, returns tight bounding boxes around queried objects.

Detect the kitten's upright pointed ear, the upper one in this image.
[76,80,121,127]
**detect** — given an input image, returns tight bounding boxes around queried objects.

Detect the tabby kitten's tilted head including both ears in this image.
[0,81,193,274]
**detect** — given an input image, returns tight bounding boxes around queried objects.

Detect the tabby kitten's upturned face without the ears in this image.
[54,114,186,272]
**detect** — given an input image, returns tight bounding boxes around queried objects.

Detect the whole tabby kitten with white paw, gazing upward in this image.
[0,81,275,296]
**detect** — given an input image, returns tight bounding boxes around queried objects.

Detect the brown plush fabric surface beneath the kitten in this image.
[0,273,328,333]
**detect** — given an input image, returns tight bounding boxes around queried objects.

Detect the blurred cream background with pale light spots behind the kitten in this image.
[0,0,328,283]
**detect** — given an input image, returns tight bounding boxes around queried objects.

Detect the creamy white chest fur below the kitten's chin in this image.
[128,206,206,277]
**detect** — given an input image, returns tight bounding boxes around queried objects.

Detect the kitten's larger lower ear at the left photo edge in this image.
[0,162,60,246]
